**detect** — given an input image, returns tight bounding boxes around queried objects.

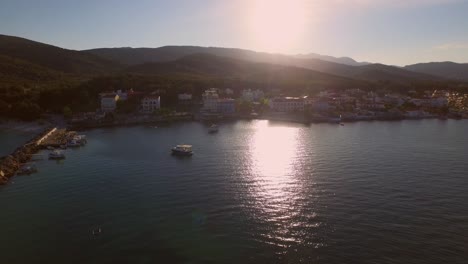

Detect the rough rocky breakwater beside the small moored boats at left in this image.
[0,129,51,185]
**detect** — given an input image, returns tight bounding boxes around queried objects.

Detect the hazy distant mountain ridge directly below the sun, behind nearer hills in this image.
[85,46,446,81]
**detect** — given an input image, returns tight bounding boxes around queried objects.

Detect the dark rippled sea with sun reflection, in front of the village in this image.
[0,120,468,263]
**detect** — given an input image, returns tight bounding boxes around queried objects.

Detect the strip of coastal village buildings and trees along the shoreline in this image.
[82,85,468,125]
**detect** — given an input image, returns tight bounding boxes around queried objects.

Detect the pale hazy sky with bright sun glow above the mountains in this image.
[0,0,468,65]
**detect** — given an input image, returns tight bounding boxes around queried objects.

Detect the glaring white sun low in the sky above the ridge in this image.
[247,0,307,52]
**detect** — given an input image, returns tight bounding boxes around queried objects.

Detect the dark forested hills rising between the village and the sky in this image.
[0,35,467,119]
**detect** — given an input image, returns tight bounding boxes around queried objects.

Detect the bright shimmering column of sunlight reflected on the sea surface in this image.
[245,121,317,248]
